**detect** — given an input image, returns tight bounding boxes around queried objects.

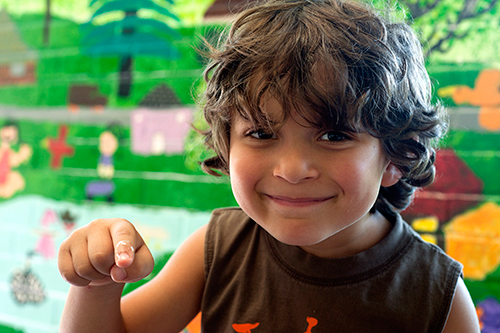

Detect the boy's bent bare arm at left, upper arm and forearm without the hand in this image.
[60,226,206,333]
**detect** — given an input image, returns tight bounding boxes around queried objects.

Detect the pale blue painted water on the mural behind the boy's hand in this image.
[0,196,210,333]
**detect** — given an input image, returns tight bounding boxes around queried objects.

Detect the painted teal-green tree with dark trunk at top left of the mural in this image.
[82,0,179,97]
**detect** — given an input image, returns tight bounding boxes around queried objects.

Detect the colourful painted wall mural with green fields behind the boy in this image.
[0,0,500,333]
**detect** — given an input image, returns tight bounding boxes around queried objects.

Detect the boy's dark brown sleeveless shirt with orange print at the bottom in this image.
[202,208,462,333]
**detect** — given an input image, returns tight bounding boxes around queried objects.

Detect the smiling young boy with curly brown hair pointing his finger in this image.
[59,0,479,333]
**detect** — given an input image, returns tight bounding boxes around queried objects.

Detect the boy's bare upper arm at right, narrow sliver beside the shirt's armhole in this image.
[443,278,480,333]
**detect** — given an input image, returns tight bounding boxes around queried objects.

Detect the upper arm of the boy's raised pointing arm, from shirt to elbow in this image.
[121,225,207,333]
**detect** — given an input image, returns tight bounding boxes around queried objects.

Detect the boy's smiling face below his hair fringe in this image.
[229,99,398,256]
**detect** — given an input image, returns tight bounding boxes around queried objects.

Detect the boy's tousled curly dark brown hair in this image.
[202,0,447,213]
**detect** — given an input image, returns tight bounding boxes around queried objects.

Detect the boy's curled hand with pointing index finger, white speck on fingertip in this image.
[58,219,154,286]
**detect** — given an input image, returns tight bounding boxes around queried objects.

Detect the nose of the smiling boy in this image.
[273,146,319,184]
